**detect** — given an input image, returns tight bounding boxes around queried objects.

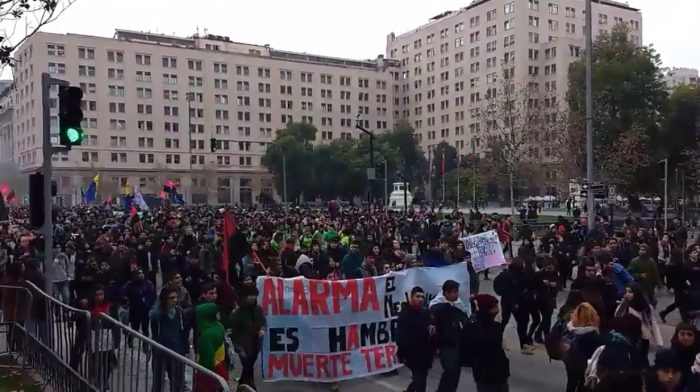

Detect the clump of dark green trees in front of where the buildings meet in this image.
[262,123,426,201]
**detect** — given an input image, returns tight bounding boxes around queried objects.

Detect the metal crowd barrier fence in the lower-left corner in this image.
[0,282,231,392]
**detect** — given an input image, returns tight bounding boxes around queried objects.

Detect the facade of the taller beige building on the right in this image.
[387,0,642,185]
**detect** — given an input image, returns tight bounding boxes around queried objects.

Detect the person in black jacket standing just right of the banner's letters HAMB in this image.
[396,286,435,392]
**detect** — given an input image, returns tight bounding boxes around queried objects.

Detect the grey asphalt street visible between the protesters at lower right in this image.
[257,277,680,392]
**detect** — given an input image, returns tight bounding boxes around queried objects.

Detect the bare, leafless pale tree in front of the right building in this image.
[478,62,557,214]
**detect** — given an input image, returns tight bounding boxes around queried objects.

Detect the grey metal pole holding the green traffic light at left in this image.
[41,73,70,282]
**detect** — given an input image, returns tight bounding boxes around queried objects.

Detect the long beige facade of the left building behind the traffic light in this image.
[8,30,399,204]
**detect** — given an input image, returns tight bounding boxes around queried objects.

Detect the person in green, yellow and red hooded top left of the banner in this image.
[194,303,228,392]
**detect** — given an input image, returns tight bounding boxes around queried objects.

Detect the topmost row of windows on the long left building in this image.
[46,44,387,90]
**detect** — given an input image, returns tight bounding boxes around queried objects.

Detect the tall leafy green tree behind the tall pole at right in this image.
[566,24,668,192]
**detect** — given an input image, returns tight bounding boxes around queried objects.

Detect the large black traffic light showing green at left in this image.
[58,86,85,148]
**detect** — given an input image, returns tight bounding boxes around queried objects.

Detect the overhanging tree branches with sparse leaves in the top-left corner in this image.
[0,0,76,65]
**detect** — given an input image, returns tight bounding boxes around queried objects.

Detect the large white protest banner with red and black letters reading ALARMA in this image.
[257,263,469,382]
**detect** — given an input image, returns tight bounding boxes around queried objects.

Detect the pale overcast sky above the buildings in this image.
[0,0,700,77]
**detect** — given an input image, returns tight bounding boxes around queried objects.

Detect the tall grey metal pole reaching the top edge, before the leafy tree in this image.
[584,0,595,229]
